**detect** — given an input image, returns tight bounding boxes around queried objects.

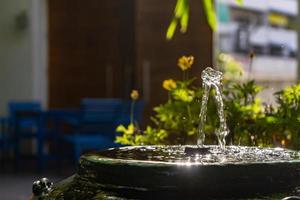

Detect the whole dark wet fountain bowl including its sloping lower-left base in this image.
[35,146,300,200]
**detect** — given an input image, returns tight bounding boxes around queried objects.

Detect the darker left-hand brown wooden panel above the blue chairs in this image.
[48,0,134,108]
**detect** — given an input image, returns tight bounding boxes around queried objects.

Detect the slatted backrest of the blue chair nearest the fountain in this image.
[80,99,122,133]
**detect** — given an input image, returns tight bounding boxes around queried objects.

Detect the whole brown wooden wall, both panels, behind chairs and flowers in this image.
[48,0,212,113]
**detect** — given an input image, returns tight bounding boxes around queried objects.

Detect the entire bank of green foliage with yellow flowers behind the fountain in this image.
[116,55,300,149]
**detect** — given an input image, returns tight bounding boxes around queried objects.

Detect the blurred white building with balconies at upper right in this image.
[215,0,299,102]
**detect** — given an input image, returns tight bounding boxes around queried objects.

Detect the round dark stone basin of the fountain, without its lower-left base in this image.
[77,146,300,198]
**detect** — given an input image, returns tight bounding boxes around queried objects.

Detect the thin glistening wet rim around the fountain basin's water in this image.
[80,145,300,167]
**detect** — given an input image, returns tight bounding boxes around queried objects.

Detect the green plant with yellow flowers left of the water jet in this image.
[116,56,202,145]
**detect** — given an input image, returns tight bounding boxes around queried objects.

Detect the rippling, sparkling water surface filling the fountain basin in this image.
[94,145,300,165]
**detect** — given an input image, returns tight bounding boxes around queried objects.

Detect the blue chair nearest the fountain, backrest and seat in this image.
[64,99,123,161]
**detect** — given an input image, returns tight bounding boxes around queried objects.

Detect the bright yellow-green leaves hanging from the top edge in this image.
[166,0,243,40]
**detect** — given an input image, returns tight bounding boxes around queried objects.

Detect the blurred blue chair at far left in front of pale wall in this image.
[8,101,45,170]
